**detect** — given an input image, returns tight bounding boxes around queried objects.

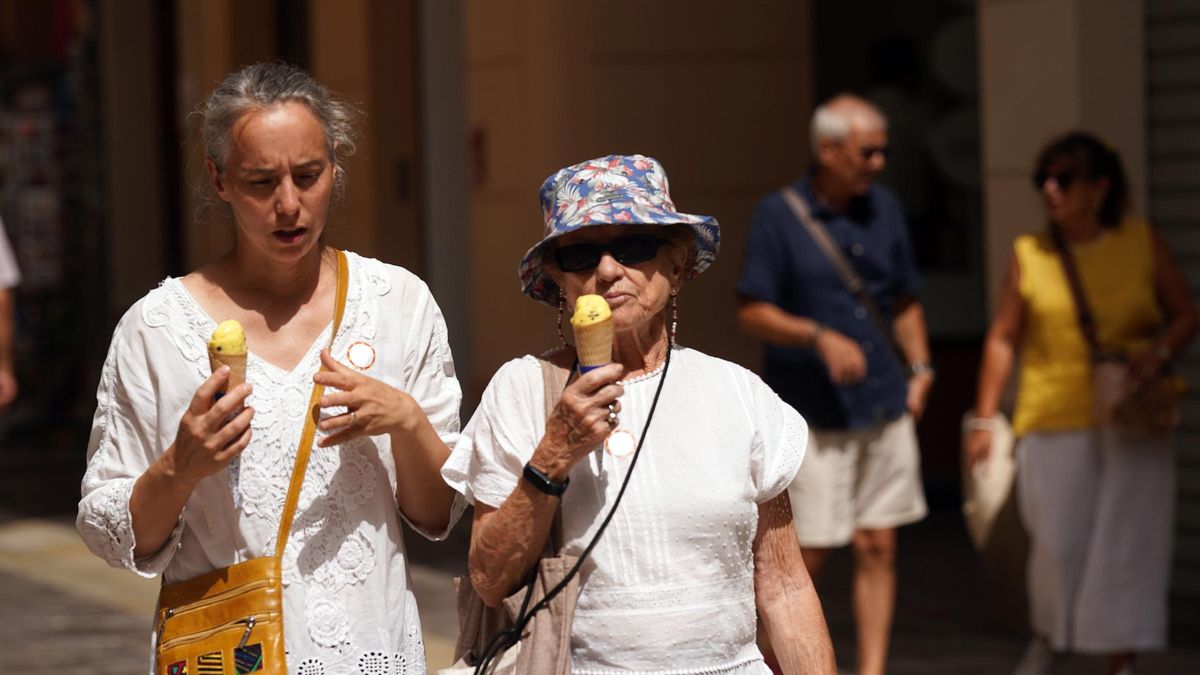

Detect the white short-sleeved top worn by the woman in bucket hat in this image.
[442,348,808,675]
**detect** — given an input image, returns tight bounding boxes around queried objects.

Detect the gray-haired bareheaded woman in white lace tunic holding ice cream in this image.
[77,64,461,675]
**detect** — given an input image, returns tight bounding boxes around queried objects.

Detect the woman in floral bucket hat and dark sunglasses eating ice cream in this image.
[442,155,834,675]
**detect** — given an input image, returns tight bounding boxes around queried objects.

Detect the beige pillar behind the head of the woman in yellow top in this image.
[979,0,1146,306]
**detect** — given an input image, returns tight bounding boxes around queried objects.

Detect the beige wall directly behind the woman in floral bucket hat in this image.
[463,0,812,392]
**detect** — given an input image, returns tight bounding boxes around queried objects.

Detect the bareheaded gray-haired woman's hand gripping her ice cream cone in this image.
[163,366,254,485]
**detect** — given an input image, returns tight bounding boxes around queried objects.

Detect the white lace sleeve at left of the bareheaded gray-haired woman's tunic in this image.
[76,311,182,577]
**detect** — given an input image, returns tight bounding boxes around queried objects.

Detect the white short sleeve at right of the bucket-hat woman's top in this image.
[744,371,809,504]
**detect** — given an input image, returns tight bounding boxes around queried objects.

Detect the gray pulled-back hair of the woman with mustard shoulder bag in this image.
[194,62,359,195]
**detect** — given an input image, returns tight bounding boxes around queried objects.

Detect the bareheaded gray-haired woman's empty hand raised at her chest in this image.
[312,350,425,448]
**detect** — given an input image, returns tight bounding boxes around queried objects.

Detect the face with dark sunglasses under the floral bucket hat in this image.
[546,225,686,333]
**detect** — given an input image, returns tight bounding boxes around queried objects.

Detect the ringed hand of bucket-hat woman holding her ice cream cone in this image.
[533,364,625,478]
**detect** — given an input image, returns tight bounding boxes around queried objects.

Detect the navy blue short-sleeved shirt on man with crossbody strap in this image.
[737,177,920,429]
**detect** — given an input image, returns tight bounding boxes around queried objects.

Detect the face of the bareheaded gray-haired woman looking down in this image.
[208,101,334,261]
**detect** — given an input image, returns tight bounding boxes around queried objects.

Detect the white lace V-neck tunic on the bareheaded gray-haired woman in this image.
[77,253,463,675]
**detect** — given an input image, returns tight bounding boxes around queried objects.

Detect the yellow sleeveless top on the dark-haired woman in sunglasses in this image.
[1013,219,1163,434]
